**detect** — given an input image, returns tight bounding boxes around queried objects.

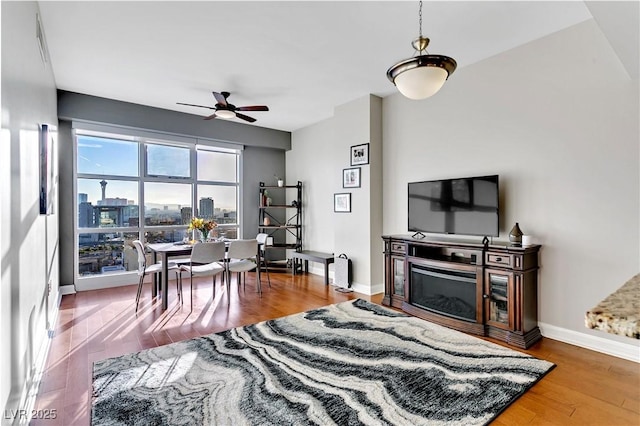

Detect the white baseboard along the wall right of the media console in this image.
[538,323,640,363]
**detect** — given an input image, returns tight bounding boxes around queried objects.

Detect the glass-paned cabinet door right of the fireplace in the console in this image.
[484,269,515,330]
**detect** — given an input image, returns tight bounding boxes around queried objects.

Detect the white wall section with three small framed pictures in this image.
[286,95,383,294]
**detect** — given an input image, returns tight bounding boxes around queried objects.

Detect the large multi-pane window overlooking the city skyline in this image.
[75,129,241,279]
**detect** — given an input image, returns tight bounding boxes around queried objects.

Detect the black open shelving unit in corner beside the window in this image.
[258,181,302,262]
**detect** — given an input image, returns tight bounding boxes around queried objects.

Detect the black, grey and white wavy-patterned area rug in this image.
[91,299,554,425]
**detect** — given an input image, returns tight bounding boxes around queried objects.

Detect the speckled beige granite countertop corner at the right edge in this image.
[585,274,640,339]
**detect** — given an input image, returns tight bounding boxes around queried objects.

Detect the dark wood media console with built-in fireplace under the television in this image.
[382,235,542,349]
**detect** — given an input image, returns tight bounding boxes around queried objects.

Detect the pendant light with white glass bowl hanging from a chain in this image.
[387,1,458,99]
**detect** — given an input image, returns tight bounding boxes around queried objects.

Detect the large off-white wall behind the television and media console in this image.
[383,21,640,352]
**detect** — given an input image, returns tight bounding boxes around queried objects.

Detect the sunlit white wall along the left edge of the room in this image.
[0,2,58,424]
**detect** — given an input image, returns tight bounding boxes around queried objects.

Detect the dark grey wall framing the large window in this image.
[58,91,291,285]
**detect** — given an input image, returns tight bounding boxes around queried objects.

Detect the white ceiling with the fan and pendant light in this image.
[33,1,624,131]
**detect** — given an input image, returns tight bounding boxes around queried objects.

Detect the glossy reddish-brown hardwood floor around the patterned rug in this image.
[32,272,640,426]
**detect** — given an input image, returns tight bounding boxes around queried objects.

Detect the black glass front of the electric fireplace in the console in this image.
[410,264,477,322]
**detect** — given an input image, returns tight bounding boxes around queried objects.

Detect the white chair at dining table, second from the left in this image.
[179,241,226,310]
